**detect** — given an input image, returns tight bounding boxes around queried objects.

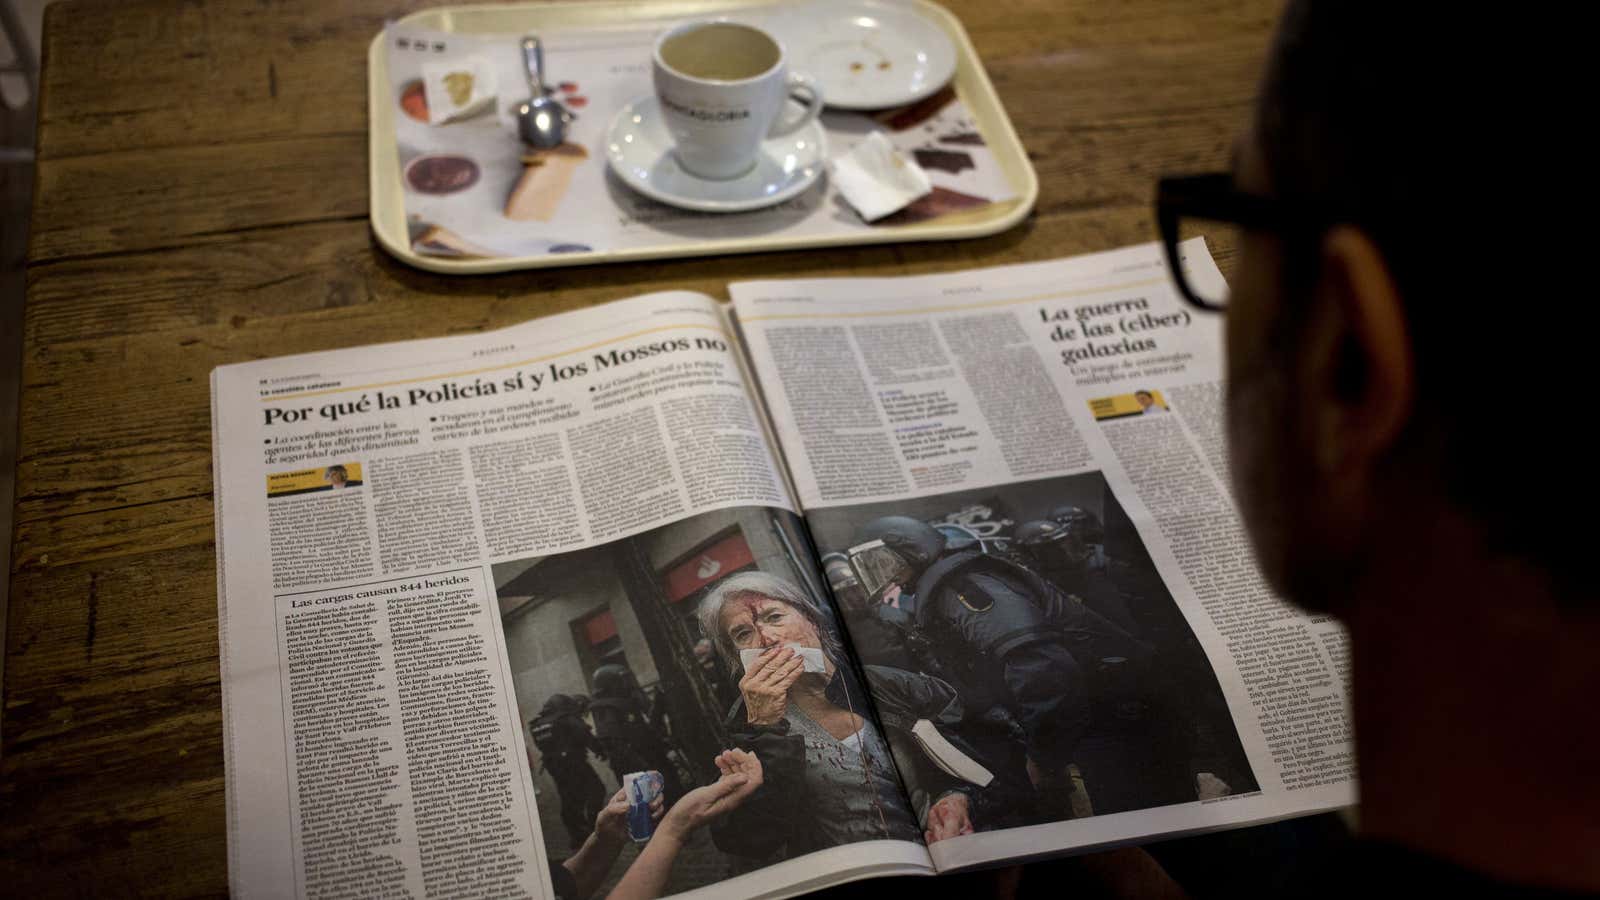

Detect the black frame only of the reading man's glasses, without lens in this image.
[1155,171,1322,312]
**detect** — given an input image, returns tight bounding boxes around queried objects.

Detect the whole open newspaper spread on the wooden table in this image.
[213,242,1354,898]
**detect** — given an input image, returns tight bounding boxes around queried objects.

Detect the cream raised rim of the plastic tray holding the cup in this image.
[366,0,1038,274]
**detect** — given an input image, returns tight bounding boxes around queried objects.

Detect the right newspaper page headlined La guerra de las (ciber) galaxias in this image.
[730,240,1355,871]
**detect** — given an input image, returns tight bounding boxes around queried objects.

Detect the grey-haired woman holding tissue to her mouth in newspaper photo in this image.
[696,572,973,858]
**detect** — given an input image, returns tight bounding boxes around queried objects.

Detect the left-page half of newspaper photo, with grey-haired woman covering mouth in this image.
[493,508,938,895]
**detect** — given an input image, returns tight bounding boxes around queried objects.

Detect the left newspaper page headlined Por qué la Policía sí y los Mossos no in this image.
[213,291,931,900]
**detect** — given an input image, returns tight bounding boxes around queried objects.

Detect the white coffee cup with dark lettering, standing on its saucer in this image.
[653,19,822,179]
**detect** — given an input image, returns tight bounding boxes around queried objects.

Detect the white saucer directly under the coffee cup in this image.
[605,96,827,213]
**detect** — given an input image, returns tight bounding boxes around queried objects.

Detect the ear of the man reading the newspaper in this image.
[1299,226,1416,477]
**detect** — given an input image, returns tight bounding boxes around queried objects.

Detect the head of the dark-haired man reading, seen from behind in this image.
[1227,0,1576,609]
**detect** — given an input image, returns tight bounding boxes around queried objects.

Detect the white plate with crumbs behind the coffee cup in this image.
[781,0,955,109]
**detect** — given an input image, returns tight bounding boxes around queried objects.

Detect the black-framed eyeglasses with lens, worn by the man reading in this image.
[1155,171,1306,312]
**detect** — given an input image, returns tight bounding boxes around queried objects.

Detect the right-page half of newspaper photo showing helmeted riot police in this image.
[808,472,1258,831]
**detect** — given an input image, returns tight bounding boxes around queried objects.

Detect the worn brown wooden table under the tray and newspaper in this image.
[0,0,1278,895]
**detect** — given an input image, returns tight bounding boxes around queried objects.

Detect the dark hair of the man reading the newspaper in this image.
[1256,0,1592,586]
